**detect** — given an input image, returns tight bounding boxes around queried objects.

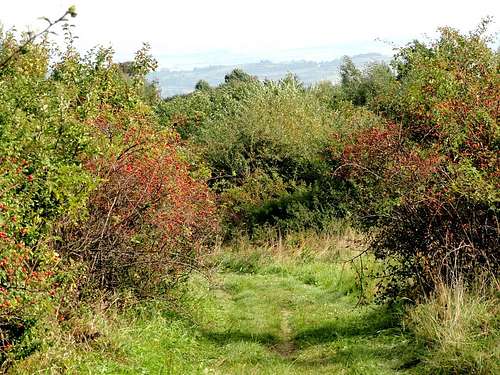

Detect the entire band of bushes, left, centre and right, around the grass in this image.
[0,10,500,372]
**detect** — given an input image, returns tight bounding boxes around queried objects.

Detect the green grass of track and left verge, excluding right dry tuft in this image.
[11,235,424,374]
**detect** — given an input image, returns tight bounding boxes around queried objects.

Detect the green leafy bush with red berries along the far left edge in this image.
[0,27,96,362]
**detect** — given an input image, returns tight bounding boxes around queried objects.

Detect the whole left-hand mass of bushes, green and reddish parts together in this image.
[0,9,217,361]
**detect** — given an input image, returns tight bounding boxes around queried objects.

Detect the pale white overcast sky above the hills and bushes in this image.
[0,0,500,69]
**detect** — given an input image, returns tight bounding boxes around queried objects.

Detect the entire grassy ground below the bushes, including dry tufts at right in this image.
[10,232,499,375]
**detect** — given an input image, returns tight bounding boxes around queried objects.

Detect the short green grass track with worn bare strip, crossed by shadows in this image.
[193,273,420,374]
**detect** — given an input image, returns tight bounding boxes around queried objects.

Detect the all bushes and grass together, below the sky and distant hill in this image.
[0,8,500,374]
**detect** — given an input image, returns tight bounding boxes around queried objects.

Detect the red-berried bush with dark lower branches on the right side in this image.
[336,22,500,298]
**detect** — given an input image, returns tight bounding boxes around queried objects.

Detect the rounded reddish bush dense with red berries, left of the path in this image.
[57,121,217,297]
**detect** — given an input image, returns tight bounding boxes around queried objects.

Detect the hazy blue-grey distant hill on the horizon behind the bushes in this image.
[149,53,390,97]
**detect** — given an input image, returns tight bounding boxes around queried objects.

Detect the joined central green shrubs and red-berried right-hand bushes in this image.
[159,20,500,299]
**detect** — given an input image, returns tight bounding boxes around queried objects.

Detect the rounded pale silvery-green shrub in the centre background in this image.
[196,80,331,184]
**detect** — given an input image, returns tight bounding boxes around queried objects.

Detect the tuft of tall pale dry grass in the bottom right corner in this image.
[407,280,500,374]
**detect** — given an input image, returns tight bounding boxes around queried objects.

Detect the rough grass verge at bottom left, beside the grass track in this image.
[9,301,213,374]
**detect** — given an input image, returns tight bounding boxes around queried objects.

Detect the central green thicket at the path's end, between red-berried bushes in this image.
[158,72,379,238]
